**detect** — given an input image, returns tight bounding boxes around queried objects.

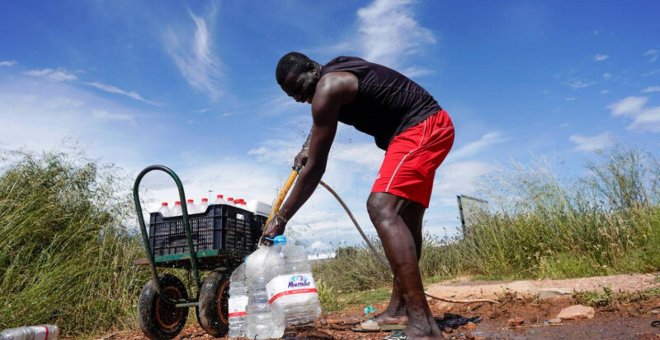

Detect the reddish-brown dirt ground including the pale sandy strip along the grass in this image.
[103,274,660,340]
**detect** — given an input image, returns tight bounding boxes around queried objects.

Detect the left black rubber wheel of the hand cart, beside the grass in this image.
[138,274,188,339]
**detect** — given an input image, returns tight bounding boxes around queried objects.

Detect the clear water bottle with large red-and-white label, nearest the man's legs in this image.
[266,235,321,325]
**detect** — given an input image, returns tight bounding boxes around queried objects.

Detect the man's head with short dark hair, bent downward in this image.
[275,52,321,103]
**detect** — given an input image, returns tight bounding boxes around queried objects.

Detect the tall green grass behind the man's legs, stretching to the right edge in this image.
[315,147,660,292]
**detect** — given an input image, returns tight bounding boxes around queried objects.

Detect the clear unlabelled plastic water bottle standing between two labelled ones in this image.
[246,247,286,339]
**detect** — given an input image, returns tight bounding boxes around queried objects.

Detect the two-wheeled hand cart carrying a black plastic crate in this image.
[133,165,267,339]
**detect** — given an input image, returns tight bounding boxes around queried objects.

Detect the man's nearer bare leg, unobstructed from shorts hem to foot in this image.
[367,192,442,337]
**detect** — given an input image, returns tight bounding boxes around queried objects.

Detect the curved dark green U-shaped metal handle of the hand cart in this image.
[133,165,202,299]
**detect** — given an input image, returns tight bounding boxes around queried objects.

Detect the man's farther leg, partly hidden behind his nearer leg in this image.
[376,202,426,325]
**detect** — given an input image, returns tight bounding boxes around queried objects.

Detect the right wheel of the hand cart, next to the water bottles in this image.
[197,272,229,337]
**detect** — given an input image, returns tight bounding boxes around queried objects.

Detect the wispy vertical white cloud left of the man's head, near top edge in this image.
[165,5,223,100]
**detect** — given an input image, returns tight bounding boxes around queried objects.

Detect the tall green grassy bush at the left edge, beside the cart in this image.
[0,153,146,336]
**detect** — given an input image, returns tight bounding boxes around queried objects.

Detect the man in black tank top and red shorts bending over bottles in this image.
[264,52,454,339]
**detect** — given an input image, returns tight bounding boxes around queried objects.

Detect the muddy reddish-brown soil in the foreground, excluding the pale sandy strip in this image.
[103,295,660,340]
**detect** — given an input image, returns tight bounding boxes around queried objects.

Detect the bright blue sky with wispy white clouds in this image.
[0,0,660,251]
